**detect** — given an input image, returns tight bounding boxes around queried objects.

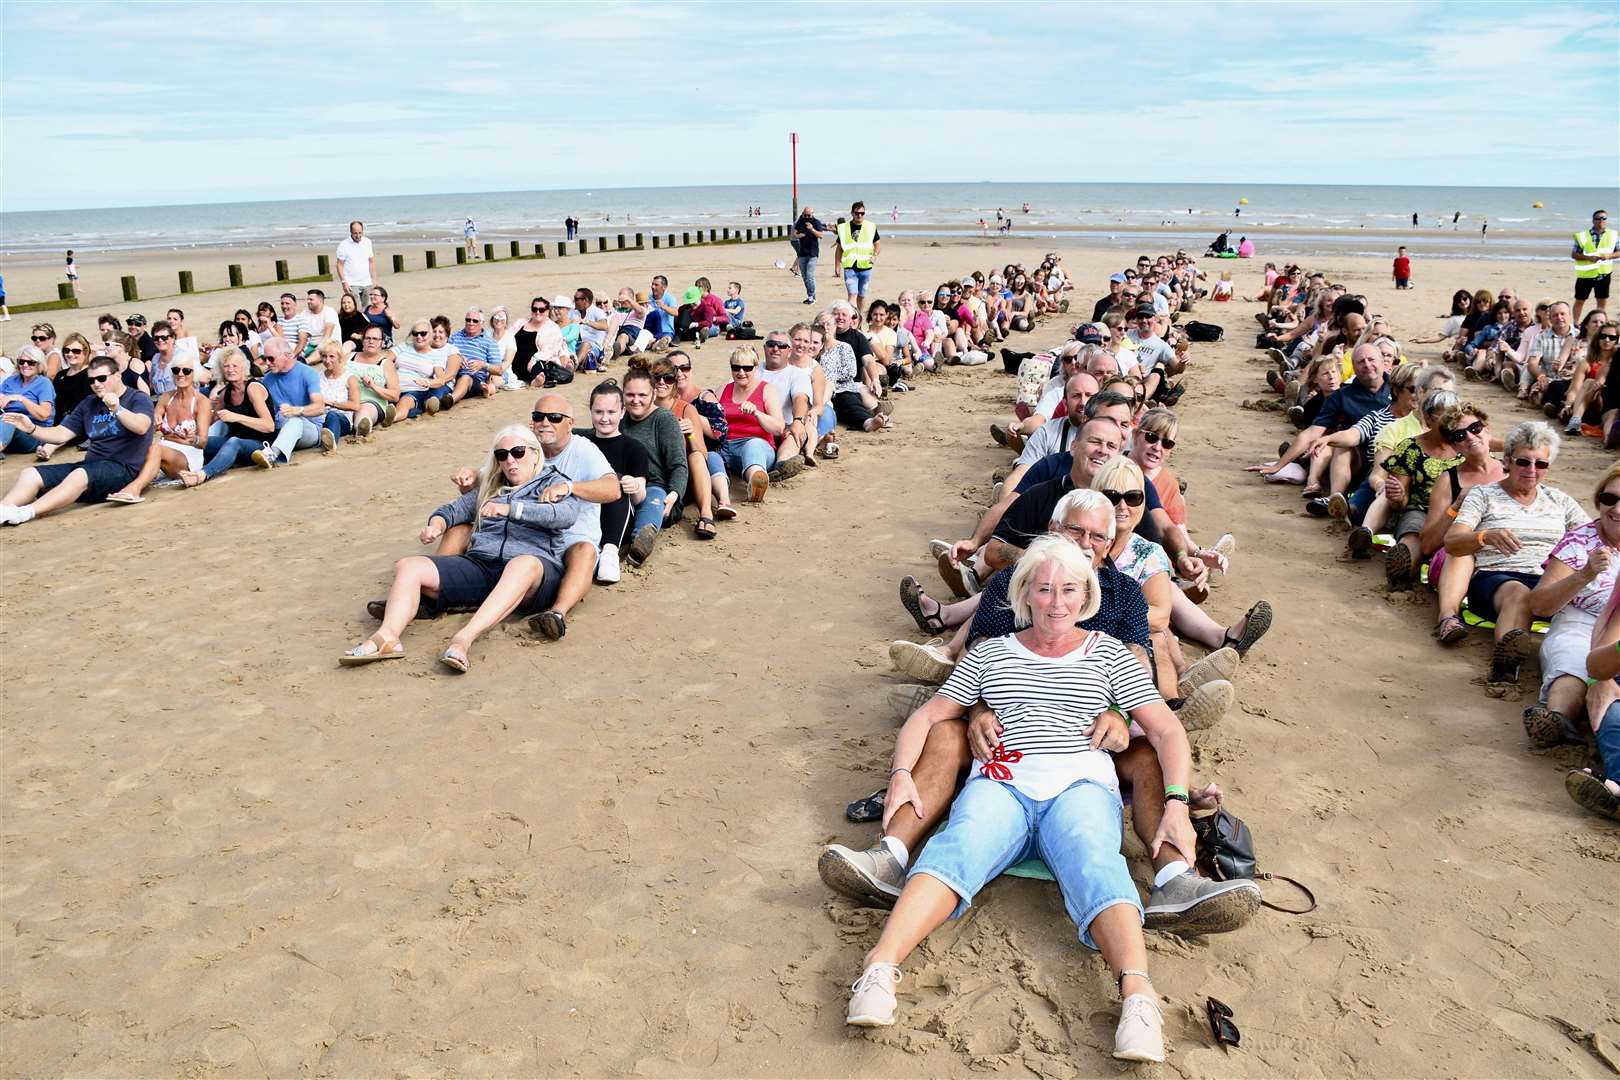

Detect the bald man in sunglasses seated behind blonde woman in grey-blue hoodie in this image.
[439,393,624,641]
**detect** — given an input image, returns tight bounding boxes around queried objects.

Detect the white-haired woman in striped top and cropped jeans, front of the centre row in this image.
[847,536,1194,1061]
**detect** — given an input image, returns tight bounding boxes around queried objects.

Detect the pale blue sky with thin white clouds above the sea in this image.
[0,0,1620,210]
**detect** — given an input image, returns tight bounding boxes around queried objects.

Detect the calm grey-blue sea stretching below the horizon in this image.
[0,183,1620,262]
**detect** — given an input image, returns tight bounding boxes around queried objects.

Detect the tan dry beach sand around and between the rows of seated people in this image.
[0,234,1620,1077]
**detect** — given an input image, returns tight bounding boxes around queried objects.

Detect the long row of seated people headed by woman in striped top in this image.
[818,253,1296,1061]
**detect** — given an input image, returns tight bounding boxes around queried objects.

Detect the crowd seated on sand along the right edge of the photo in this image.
[1251,267,1620,818]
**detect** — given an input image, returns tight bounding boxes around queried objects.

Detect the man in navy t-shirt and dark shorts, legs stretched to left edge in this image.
[0,356,154,525]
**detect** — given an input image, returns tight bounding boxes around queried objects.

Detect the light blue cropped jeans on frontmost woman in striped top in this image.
[907,776,1142,949]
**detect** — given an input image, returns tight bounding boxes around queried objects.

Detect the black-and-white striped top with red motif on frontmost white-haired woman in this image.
[940,630,1160,800]
